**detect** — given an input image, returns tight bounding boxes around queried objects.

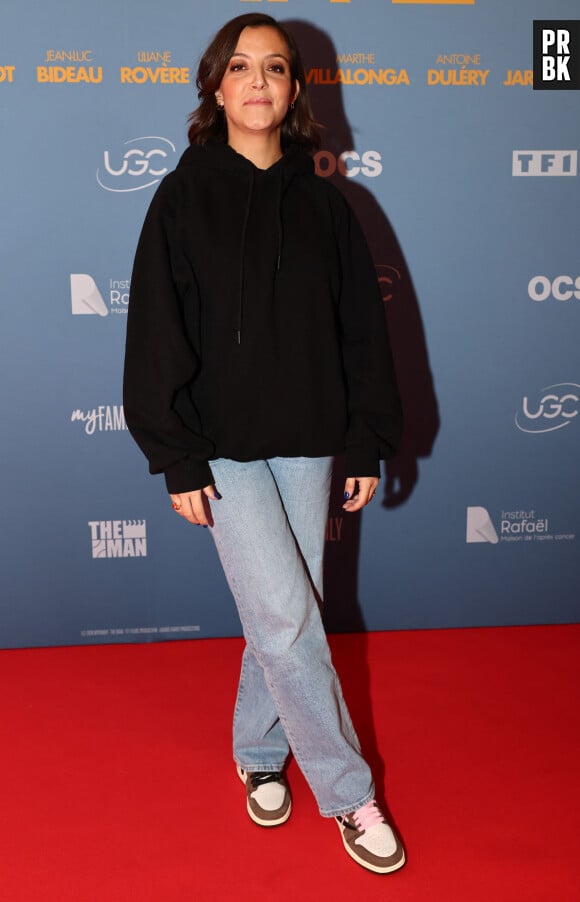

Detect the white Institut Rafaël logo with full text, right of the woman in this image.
[465,506,576,545]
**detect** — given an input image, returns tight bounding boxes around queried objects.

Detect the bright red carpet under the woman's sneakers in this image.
[0,626,580,902]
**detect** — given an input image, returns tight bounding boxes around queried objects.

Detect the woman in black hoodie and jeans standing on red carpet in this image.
[125,14,405,873]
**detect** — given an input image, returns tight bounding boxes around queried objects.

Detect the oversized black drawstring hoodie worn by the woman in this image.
[124,140,401,493]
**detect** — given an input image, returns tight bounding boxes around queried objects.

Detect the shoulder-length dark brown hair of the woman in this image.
[188,13,320,151]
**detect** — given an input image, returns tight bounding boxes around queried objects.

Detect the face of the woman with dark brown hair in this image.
[216,26,299,142]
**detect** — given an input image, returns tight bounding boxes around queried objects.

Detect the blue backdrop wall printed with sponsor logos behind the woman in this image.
[0,0,580,647]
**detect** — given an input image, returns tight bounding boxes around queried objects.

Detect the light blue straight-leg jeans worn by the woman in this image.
[210,457,374,817]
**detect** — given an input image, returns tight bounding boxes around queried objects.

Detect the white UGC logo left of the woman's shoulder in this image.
[97,135,175,193]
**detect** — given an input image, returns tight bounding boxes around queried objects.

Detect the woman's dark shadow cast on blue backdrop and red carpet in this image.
[284,20,439,793]
